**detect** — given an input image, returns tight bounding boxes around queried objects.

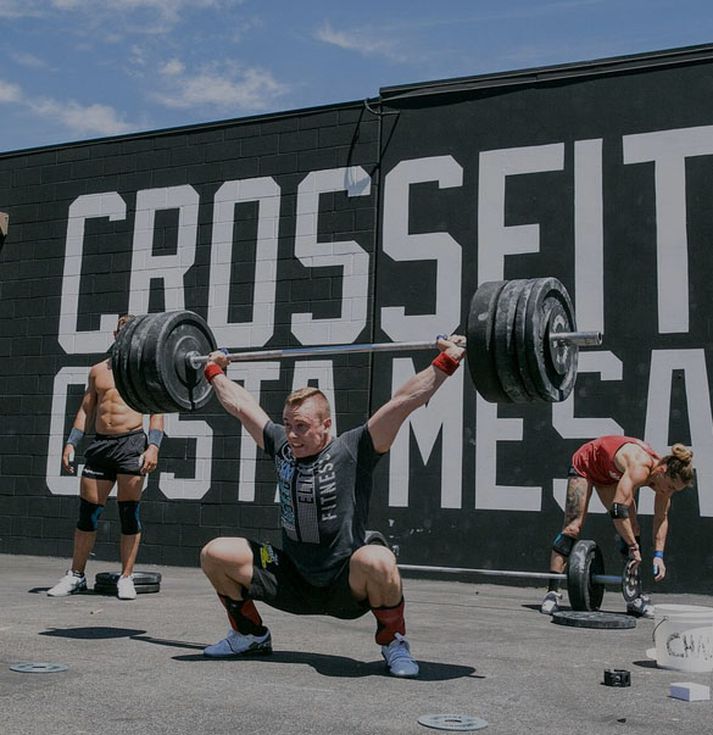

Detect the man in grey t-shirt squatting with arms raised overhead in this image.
[201,335,465,677]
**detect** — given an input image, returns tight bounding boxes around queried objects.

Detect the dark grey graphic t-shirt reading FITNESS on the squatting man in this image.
[263,421,382,587]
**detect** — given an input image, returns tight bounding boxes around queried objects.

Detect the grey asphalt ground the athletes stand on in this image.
[0,555,713,735]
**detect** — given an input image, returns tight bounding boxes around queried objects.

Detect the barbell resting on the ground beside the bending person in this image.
[390,531,641,610]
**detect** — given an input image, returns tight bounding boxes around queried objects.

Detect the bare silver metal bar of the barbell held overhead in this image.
[186,332,602,370]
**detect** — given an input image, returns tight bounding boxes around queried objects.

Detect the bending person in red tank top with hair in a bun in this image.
[540,435,693,617]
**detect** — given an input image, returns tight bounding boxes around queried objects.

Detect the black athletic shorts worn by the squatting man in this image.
[246,539,371,620]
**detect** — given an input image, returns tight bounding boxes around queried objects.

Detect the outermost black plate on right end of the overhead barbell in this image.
[524,278,578,402]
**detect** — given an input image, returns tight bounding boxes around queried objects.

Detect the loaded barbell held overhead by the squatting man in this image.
[111,277,602,414]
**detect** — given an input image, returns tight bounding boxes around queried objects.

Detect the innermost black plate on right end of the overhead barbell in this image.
[466,281,512,403]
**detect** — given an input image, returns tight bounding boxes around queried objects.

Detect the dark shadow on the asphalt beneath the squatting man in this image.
[132,635,485,681]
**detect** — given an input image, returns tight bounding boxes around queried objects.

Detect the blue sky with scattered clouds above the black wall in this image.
[0,0,713,151]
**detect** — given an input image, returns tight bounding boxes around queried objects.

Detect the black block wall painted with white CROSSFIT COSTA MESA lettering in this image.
[0,49,713,592]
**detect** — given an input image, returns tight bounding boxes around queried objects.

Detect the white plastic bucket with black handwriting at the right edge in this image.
[654,605,713,672]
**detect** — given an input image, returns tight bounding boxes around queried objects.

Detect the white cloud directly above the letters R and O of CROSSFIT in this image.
[153,68,287,112]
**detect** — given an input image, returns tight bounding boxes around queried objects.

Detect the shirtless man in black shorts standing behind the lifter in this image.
[47,314,163,600]
